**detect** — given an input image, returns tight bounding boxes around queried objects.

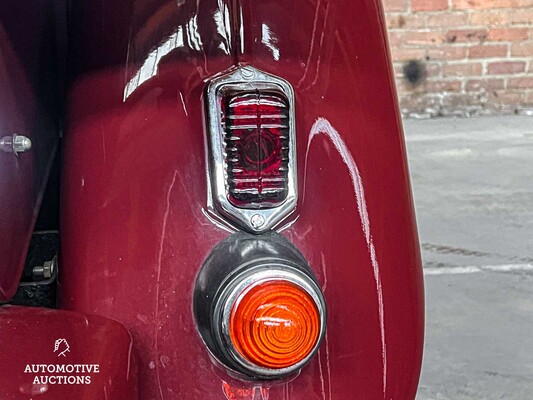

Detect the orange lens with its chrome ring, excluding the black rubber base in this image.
[214,264,326,378]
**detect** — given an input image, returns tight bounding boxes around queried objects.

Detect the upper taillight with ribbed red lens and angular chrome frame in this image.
[206,66,297,233]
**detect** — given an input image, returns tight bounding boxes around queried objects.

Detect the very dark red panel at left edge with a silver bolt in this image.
[0,0,58,302]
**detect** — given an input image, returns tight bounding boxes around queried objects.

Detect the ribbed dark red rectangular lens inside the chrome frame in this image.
[223,91,289,208]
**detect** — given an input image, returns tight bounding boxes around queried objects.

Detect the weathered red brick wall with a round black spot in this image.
[383,0,533,117]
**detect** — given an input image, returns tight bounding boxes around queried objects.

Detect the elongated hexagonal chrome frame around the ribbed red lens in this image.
[206,66,298,233]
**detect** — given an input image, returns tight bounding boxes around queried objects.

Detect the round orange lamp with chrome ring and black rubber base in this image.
[194,233,326,379]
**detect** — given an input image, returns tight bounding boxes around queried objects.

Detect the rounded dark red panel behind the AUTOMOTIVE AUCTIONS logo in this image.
[0,306,137,400]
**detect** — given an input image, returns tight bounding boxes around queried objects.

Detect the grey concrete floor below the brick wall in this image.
[404,116,533,400]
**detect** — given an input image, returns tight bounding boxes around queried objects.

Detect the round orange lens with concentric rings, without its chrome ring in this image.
[229,280,320,369]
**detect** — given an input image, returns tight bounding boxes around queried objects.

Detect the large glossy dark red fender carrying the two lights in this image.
[61,0,423,400]
